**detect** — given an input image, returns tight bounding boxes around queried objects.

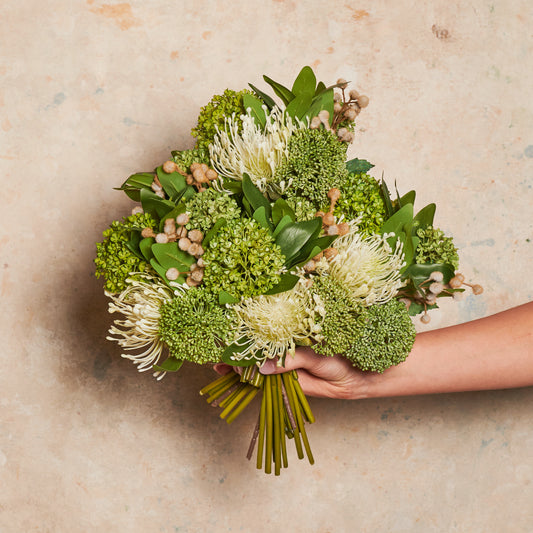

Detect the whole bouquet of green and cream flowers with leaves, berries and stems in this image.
[95,67,482,474]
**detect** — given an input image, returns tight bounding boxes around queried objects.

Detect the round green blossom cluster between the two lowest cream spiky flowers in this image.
[159,288,233,364]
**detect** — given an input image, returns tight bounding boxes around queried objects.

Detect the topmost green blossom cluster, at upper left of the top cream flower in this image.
[191,89,251,151]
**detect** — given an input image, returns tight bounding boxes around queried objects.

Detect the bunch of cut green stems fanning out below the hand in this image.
[200,367,315,476]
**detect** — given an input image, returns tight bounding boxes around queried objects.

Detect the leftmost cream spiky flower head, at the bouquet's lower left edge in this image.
[106,274,185,379]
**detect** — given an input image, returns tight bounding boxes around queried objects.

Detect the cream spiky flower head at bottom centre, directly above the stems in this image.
[232,280,321,363]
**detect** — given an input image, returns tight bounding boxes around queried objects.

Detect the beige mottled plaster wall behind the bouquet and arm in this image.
[0,0,533,533]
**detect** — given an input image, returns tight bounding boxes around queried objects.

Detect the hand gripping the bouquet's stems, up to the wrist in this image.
[215,347,373,399]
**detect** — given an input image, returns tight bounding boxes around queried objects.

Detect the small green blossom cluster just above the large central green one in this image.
[185,187,241,231]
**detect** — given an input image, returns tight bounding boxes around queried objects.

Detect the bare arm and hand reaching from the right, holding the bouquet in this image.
[215,302,533,399]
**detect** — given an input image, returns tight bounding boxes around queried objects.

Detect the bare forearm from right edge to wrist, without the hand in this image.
[366,302,533,398]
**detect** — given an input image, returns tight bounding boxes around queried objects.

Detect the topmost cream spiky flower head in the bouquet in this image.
[209,106,306,196]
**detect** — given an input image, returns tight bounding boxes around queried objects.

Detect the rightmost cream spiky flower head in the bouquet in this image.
[329,231,405,306]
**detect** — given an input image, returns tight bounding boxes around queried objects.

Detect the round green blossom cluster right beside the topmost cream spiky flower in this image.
[275,128,348,209]
